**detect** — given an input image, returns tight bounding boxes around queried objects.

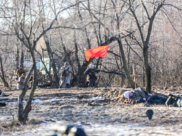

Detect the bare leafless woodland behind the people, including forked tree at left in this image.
[0,0,182,122]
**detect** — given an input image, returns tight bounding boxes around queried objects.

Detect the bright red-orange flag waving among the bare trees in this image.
[85,45,109,61]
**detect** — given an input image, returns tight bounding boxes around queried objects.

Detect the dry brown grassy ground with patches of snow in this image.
[0,87,182,136]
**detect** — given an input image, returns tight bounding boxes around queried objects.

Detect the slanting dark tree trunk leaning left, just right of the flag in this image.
[117,39,135,89]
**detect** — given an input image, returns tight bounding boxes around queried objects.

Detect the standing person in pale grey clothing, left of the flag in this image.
[60,62,73,88]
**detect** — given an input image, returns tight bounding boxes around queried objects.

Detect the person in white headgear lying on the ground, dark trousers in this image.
[124,87,167,104]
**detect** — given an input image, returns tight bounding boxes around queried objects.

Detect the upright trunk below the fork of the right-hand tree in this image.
[143,46,151,93]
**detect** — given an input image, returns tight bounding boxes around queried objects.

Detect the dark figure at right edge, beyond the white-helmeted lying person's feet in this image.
[165,93,182,107]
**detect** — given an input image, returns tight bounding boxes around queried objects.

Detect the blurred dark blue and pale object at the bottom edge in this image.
[42,125,87,136]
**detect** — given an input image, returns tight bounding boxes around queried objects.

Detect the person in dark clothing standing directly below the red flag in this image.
[85,64,101,87]
